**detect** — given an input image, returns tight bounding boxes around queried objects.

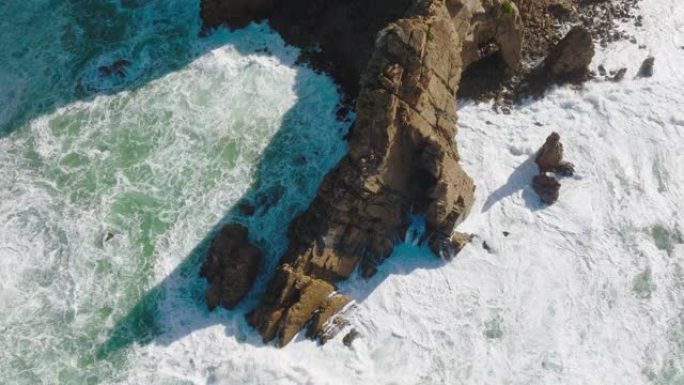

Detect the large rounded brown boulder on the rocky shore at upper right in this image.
[544,27,594,80]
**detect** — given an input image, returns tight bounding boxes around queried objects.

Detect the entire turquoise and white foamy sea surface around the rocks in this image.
[0,0,684,385]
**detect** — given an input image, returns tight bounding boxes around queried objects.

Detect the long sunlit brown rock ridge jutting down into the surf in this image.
[249,1,474,345]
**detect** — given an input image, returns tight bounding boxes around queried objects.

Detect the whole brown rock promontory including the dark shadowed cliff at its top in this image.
[202,0,522,346]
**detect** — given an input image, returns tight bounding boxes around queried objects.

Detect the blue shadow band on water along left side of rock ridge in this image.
[81,17,350,360]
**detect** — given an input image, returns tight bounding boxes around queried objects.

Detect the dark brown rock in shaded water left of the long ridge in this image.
[200,224,261,310]
